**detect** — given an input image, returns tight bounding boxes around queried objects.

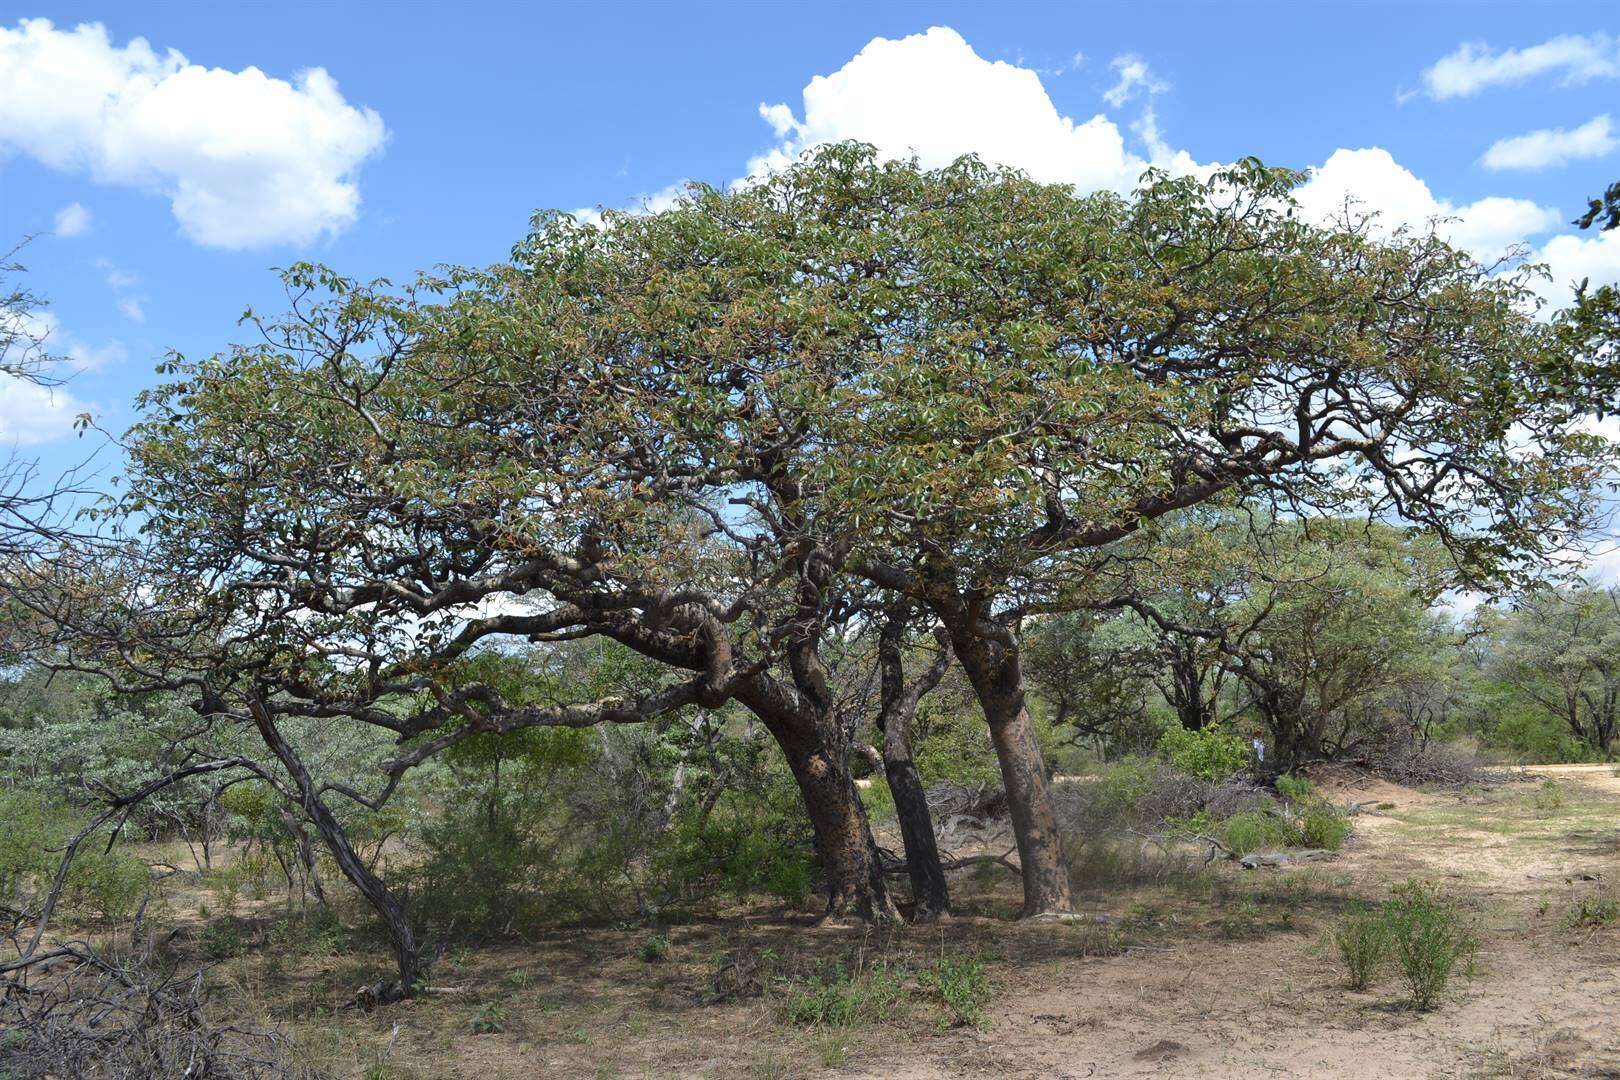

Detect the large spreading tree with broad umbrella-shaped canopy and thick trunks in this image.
[44,144,1602,918]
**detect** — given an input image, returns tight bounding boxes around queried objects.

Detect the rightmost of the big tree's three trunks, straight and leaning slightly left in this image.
[982,688,1074,916]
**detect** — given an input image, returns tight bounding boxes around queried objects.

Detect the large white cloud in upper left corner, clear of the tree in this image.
[0,19,386,248]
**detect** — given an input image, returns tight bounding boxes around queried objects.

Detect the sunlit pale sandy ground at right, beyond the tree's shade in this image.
[836,766,1620,1080]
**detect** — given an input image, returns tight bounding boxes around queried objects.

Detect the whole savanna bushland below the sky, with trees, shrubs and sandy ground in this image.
[0,144,1620,1080]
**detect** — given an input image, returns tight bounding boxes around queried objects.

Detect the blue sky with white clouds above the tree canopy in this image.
[0,0,1620,501]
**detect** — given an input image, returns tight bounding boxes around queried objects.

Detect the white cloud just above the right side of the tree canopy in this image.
[1294,147,1560,261]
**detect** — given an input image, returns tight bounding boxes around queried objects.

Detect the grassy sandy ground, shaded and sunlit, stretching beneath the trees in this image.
[202,766,1620,1080]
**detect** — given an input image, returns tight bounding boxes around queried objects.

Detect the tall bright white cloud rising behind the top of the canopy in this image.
[748,26,1150,191]
